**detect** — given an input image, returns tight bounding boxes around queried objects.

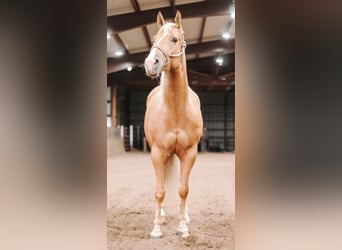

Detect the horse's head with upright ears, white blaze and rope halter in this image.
[145,11,185,78]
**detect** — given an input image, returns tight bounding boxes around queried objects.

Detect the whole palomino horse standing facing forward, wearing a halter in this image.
[144,11,203,238]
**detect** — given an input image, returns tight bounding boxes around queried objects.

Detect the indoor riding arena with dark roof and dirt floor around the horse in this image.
[107,0,235,250]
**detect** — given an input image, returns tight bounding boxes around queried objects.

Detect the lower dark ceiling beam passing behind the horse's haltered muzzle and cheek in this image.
[107,40,235,74]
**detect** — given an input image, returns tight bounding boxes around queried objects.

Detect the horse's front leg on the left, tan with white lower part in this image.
[151,147,168,239]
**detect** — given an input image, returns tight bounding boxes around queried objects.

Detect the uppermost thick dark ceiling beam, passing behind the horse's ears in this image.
[107,0,232,34]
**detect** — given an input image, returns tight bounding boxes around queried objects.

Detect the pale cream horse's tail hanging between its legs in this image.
[165,155,179,204]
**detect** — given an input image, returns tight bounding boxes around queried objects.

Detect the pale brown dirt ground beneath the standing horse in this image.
[107,152,235,250]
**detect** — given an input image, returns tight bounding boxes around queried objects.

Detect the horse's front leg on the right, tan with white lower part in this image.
[177,147,197,238]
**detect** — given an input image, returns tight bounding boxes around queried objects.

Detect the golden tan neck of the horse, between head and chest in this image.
[160,59,189,108]
